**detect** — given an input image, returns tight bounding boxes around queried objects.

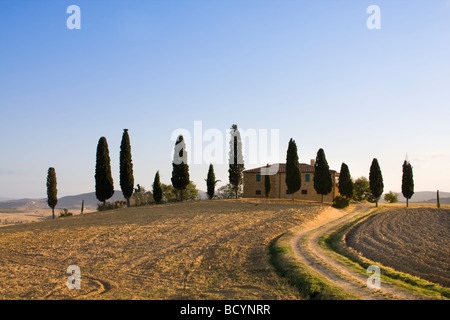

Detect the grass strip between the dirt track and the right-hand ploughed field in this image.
[319,208,450,299]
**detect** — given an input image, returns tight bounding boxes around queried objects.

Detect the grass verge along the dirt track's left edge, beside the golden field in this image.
[269,232,359,300]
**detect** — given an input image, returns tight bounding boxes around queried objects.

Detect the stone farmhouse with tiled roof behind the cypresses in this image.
[243,160,339,202]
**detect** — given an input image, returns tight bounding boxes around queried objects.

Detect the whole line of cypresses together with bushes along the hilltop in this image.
[47,124,414,218]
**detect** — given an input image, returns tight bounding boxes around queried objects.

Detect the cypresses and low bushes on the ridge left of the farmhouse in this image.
[47,124,244,219]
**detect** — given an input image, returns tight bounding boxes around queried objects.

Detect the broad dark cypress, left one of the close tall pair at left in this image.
[95,137,114,207]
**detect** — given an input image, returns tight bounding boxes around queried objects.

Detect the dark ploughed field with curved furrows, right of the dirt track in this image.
[346,207,450,287]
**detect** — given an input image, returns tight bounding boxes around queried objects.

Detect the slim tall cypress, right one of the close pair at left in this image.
[120,129,134,207]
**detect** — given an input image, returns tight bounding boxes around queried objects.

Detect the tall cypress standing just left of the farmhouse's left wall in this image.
[228,124,244,199]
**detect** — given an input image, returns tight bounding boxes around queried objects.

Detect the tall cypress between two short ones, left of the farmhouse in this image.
[172,135,189,201]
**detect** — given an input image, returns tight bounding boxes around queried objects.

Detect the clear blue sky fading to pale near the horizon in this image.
[0,0,450,198]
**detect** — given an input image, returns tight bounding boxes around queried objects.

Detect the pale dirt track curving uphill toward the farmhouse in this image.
[291,205,420,300]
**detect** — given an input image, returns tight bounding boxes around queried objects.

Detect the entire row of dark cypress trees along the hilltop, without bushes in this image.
[47,124,414,218]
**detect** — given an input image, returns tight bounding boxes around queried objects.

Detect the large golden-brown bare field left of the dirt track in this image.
[0,200,324,299]
